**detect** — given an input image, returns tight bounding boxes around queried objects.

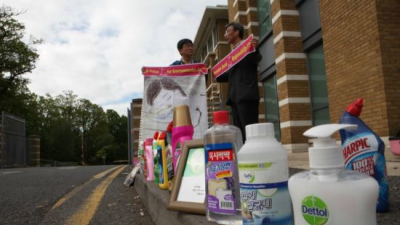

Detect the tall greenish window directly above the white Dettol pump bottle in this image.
[307,43,330,126]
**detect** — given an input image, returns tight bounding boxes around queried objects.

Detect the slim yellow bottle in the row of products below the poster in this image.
[157,131,168,190]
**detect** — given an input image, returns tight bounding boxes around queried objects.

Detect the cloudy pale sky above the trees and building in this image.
[1,0,227,115]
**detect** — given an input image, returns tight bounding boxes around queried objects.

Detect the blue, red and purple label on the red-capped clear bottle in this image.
[205,143,239,214]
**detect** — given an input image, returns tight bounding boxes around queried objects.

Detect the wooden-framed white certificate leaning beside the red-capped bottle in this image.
[168,139,206,215]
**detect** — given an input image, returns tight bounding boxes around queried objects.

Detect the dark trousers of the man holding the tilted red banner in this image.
[231,102,259,143]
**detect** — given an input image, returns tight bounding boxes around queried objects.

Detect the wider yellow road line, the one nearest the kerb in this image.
[64,166,126,225]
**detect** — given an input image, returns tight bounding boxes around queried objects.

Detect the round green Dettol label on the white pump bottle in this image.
[301,196,329,225]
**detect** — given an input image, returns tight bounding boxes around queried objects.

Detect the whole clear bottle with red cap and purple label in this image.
[204,111,243,224]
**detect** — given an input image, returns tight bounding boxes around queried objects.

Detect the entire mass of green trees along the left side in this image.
[0,6,128,164]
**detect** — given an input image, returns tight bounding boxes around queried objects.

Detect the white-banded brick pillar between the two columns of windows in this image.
[271,0,311,152]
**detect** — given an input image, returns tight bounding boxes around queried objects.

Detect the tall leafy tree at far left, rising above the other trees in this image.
[0,6,43,105]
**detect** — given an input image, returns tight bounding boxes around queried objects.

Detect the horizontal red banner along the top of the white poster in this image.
[143,63,208,76]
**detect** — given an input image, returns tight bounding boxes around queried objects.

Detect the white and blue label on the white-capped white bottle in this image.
[239,160,293,225]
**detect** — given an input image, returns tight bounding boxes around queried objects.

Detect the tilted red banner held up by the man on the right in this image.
[212,35,256,78]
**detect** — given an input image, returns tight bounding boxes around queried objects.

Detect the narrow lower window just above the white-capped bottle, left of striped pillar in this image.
[264,74,281,141]
